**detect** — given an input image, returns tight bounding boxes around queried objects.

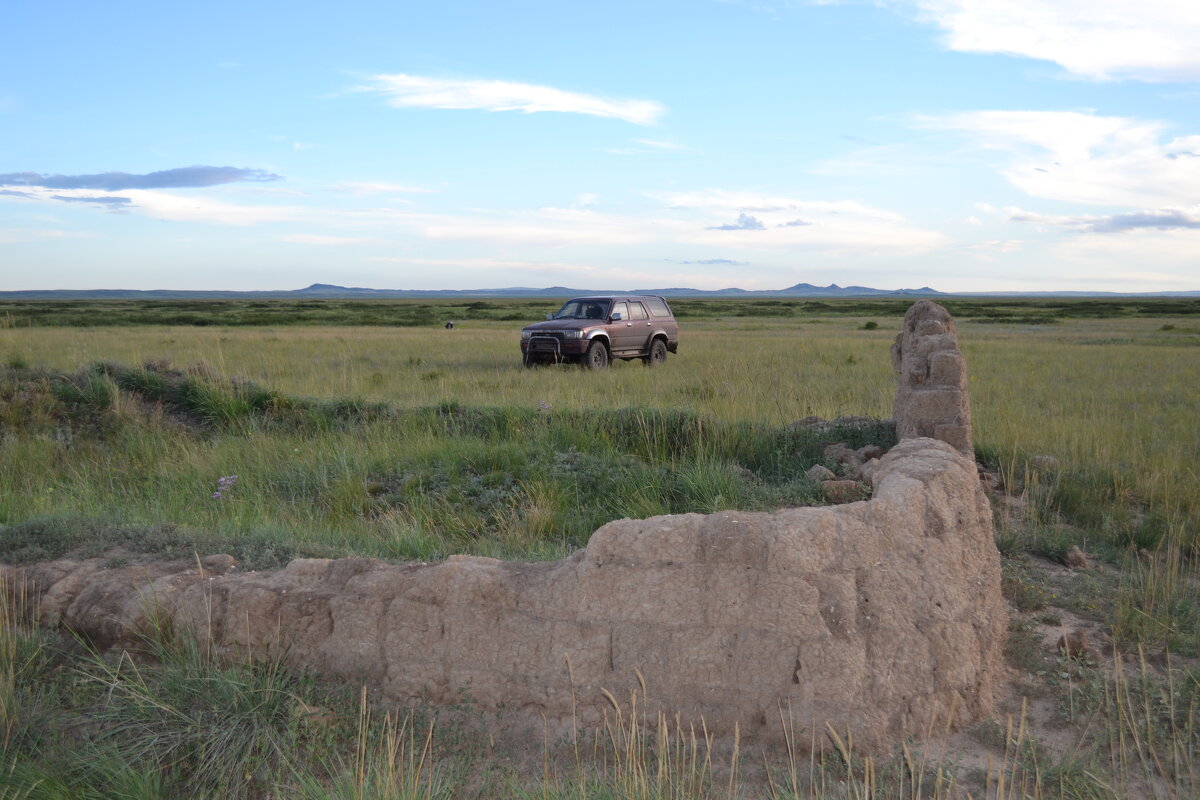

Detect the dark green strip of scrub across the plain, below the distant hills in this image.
[0,297,1200,327]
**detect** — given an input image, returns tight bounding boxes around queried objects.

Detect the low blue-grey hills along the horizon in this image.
[0,283,1200,300]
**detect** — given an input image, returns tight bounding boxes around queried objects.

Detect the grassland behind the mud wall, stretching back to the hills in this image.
[0,299,1200,798]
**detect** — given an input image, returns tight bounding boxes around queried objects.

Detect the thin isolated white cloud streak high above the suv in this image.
[361,74,666,125]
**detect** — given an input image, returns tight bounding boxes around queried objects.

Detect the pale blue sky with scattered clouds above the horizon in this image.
[0,0,1200,291]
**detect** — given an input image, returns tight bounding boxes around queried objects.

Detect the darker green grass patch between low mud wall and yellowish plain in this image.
[0,363,894,566]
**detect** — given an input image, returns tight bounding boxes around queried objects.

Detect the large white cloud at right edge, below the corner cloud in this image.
[918,110,1200,207]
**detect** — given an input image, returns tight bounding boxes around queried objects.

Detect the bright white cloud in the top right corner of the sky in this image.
[900,0,1200,82]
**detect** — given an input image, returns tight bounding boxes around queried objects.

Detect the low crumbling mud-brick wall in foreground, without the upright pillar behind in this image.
[7,299,1006,747]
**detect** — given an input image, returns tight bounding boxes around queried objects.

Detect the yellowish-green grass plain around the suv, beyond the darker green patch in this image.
[0,317,1200,549]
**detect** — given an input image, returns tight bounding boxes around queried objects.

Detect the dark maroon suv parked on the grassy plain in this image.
[521,295,679,369]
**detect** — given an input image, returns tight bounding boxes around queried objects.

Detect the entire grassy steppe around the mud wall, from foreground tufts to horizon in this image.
[0,301,1200,800]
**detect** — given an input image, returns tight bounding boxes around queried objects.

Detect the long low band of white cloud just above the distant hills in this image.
[4,176,949,258]
